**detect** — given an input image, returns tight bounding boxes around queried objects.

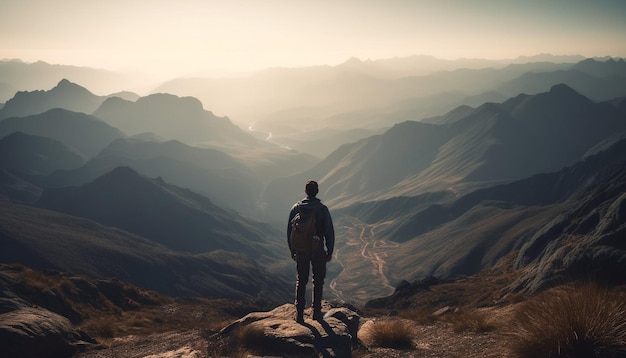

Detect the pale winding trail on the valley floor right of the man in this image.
[329,219,399,304]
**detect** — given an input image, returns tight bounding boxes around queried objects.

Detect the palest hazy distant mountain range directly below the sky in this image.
[155,55,626,158]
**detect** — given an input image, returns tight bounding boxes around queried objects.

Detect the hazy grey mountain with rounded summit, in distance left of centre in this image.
[94,93,257,146]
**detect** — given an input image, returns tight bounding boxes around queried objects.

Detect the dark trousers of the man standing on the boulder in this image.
[295,251,326,312]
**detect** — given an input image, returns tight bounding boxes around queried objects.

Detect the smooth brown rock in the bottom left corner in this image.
[0,305,97,358]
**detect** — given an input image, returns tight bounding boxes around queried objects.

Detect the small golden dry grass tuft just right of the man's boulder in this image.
[359,319,415,349]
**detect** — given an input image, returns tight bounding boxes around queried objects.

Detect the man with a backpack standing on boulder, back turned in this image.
[287,180,335,323]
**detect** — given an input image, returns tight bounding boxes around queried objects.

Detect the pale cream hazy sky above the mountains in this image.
[0,0,626,76]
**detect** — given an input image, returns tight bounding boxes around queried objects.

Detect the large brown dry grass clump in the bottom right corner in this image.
[510,284,626,357]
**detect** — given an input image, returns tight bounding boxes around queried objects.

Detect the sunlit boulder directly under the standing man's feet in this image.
[210,302,360,358]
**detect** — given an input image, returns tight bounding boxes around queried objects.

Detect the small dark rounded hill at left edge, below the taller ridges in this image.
[0,132,85,176]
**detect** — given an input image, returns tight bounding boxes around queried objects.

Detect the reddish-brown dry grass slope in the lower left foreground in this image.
[0,264,261,346]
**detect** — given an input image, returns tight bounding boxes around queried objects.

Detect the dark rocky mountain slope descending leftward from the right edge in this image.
[370,140,626,290]
